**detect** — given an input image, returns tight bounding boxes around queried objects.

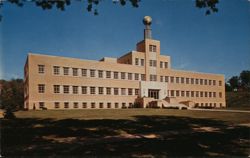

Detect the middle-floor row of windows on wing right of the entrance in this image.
[169,90,222,98]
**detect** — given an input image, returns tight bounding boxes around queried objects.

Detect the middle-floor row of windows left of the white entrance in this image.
[38,84,139,95]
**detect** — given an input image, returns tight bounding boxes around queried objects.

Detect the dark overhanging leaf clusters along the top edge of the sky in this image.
[0,0,219,21]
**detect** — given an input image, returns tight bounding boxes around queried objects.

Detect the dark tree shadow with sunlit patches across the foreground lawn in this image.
[1,116,250,157]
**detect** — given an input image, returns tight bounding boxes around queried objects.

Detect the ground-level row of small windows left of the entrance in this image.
[39,102,133,109]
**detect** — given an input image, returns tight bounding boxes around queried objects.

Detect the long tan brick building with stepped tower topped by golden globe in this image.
[24,16,226,110]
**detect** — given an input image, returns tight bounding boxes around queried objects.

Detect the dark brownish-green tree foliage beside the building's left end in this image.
[0,79,24,111]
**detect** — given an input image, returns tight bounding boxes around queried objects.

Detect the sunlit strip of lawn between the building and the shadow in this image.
[15,109,250,124]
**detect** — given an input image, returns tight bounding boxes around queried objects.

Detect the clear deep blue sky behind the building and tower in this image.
[0,0,250,79]
